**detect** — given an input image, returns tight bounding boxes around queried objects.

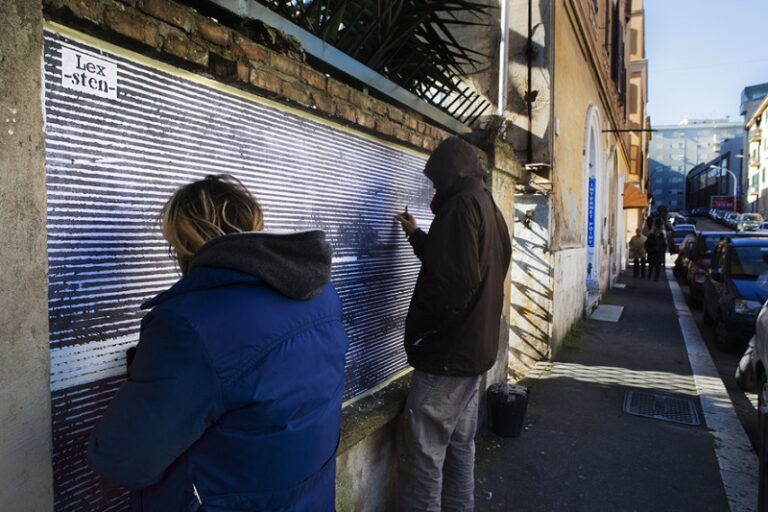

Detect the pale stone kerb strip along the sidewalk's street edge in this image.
[666,268,758,512]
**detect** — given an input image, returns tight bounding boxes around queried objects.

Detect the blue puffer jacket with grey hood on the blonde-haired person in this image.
[88,231,347,512]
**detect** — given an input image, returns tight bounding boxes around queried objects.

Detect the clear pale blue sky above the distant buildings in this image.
[645,0,768,126]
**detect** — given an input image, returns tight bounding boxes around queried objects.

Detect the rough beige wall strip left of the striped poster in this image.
[0,0,53,512]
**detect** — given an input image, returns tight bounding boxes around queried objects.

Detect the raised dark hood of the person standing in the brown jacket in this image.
[424,137,484,194]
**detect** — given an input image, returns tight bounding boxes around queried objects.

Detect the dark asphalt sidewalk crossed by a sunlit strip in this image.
[476,272,757,512]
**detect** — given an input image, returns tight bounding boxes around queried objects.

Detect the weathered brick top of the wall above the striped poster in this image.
[43,0,449,151]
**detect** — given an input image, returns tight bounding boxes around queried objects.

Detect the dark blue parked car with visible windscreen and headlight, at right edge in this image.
[704,238,768,352]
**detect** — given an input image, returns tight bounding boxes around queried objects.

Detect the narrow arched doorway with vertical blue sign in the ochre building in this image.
[584,105,604,294]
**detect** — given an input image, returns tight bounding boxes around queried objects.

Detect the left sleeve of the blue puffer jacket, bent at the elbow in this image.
[88,310,223,488]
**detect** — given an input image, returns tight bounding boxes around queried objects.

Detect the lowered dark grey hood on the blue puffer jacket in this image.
[190,231,331,300]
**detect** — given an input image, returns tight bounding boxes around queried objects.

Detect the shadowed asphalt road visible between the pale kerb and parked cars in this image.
[672,217,759,450]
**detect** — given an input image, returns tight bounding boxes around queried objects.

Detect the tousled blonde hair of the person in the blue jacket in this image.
[162,174,264,274]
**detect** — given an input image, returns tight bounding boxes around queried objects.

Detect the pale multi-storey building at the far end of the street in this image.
[648,119,744,210]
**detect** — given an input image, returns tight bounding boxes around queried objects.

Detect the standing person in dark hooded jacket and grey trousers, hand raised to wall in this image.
[395,137,511,512]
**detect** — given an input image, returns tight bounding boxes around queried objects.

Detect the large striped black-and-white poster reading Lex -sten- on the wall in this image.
[44,29,432,512]
